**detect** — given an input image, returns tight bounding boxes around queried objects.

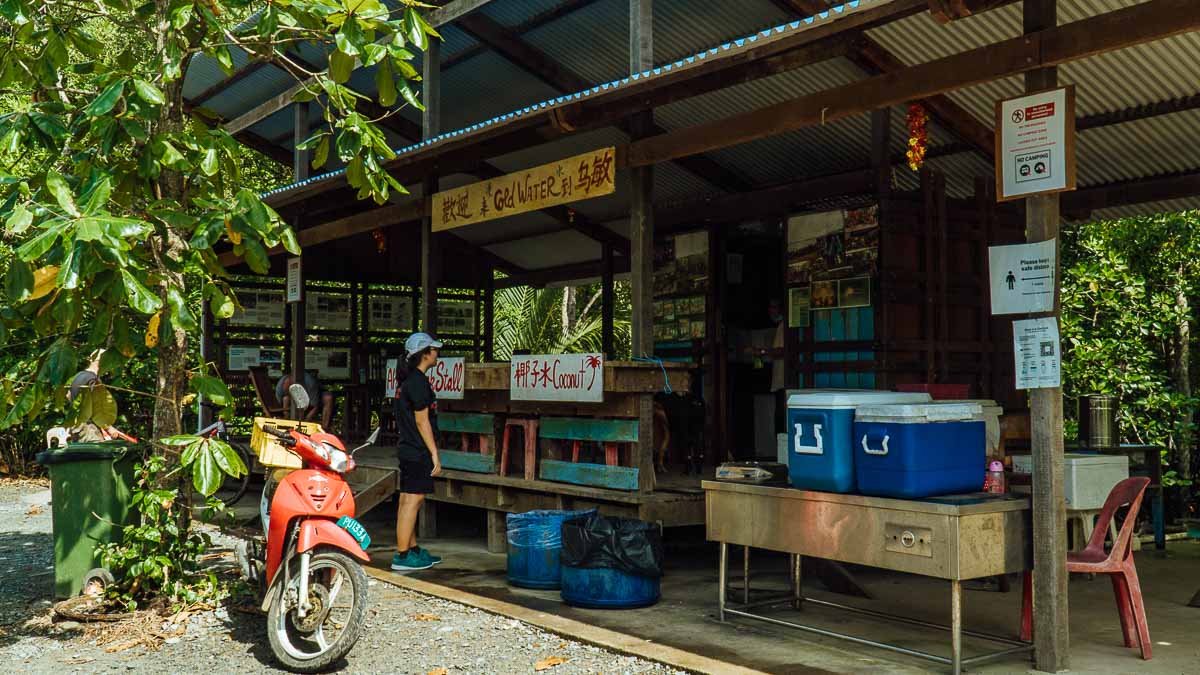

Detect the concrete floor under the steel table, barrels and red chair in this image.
[365,504,1200,674]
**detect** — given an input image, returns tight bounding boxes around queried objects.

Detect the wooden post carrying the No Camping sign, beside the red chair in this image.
[1025,0,1070,673]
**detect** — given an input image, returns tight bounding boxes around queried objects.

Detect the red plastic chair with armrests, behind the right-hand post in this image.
[1021,477,1151,661]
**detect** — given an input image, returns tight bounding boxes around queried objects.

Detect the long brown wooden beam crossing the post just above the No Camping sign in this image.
[618,0,1200,166]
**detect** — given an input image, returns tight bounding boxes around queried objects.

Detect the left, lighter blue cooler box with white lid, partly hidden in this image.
[787,389,930,492]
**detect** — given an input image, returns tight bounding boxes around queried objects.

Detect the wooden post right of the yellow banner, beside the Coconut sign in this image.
[629,0,654,485]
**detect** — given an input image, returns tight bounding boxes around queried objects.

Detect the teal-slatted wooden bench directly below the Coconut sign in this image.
[540,417,638,490]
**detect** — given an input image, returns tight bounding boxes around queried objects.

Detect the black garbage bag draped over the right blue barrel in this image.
[562,514,662,579]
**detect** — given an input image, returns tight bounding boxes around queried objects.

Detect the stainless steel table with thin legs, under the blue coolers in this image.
[702,480,1033,675]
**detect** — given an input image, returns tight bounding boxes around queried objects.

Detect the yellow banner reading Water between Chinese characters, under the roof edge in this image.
[433,148,617,232]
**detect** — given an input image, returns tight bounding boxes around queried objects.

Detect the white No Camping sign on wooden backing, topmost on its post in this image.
[996,86,1075,202]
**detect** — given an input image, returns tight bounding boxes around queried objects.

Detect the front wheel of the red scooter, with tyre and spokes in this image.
[266,549,367,673]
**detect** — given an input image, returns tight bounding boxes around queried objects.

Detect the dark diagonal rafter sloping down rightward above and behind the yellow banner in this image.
[458,14,750,190]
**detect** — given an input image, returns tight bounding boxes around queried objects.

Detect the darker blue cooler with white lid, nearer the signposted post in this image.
[854,402,988,498]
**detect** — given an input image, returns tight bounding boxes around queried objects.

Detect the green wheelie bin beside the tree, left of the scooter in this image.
[37,441,138,598]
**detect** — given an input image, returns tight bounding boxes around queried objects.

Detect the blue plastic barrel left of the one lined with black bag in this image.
[506,509,595,590]
